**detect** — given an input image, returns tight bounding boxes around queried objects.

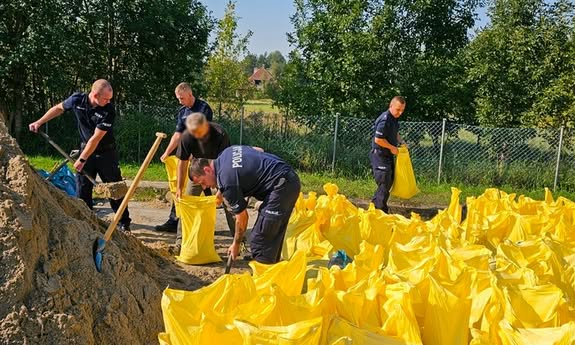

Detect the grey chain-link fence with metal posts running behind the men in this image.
[18,104,575,191]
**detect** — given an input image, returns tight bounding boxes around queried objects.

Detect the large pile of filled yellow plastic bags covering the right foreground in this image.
[158,184,575,345]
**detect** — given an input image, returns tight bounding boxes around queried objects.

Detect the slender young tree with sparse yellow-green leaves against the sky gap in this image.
[205,1,252,116]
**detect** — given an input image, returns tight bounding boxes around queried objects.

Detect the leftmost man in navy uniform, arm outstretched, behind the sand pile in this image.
[29,79,131,231]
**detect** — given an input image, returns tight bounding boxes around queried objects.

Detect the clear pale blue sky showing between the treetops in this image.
[201,0,487,57]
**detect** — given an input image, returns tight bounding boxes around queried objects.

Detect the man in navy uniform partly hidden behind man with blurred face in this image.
[155,83,213,232]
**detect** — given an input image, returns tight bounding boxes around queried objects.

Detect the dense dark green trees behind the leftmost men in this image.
[0,0,213,137]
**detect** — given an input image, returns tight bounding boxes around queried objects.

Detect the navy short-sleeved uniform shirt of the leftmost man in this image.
[62,92,116,151]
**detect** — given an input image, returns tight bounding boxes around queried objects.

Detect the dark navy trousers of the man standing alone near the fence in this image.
[369,149,395,213]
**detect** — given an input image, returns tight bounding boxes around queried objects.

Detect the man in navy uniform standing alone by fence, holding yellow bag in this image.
[369,96,405,213]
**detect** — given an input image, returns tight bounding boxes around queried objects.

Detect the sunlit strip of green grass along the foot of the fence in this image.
[28,156,575,207]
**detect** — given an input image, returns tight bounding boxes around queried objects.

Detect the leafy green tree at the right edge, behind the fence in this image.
[467,0,575,126]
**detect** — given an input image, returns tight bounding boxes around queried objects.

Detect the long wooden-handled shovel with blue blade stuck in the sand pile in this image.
[92,133,167,272]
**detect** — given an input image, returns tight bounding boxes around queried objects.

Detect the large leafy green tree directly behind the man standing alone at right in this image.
[276,0,477,120]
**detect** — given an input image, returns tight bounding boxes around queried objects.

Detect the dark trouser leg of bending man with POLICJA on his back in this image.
[250,173,301,264]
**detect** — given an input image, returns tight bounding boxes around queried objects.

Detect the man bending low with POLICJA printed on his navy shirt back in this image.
[190,145,301,264]
